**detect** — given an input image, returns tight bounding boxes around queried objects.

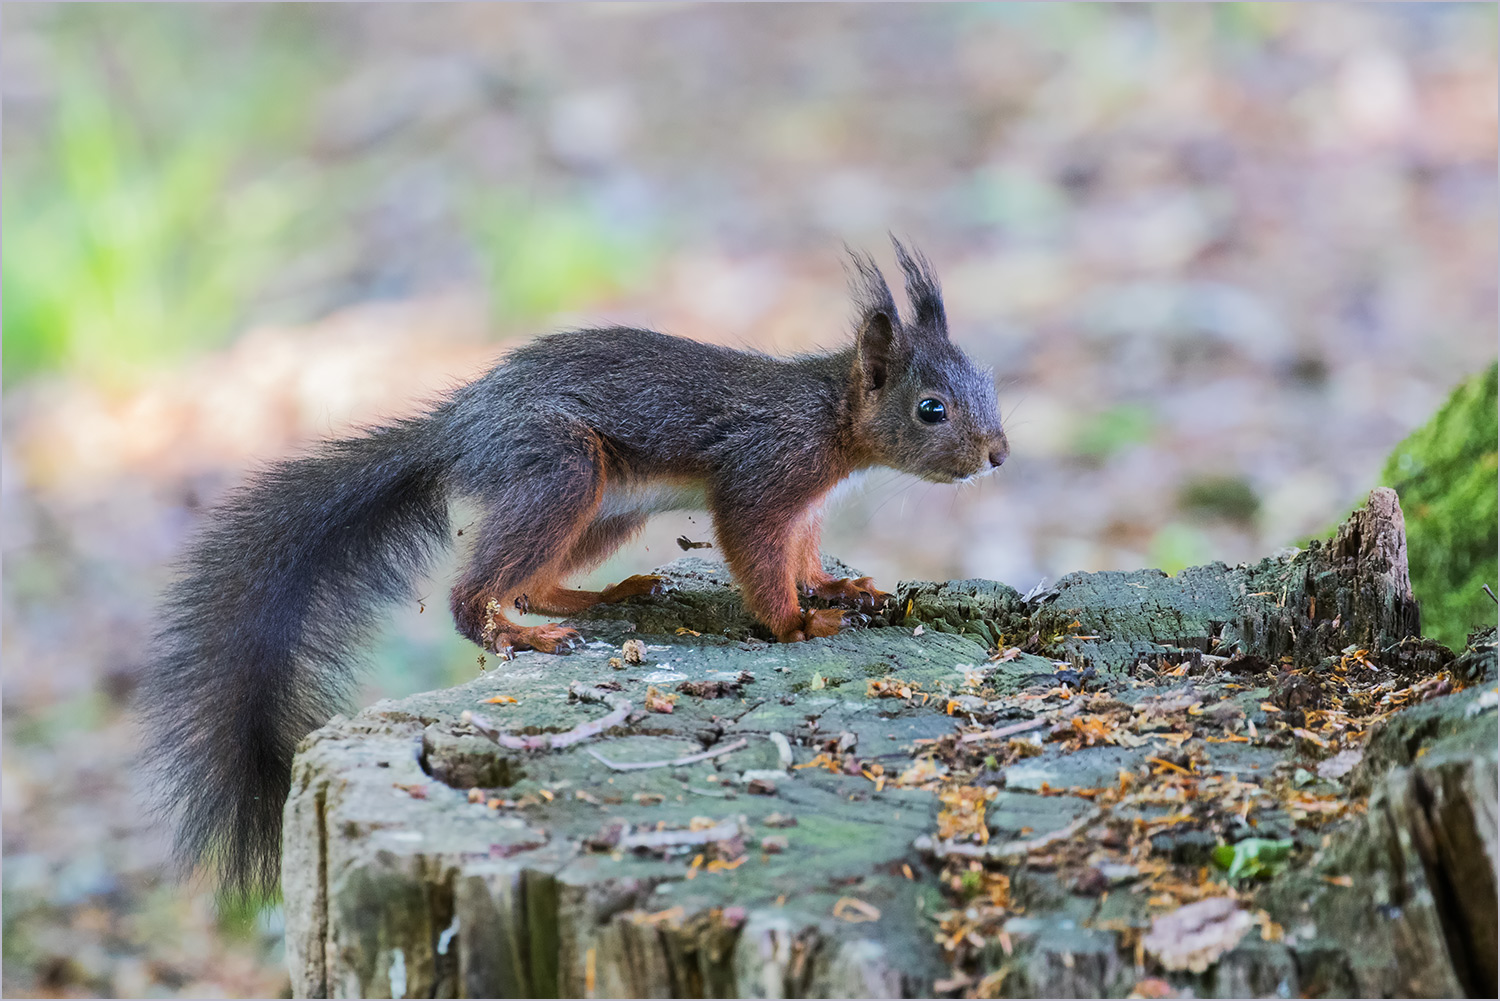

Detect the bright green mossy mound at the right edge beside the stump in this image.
[1382,365,1500,650]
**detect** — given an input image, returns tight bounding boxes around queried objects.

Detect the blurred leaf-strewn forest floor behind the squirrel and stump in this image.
[0,3,1500,996]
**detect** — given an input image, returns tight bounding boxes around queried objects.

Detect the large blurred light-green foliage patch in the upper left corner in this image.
[3,5,317,383]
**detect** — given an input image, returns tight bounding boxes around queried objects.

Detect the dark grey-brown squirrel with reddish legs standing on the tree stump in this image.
[138,239,1010,894]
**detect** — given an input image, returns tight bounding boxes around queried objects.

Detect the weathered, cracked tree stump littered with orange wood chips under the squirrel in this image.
[284,491,1496,996]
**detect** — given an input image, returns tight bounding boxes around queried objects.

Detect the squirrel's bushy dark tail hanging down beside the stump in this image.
[138,420,449,893]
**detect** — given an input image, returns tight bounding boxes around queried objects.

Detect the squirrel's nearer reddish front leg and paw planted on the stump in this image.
[714,504,843,642]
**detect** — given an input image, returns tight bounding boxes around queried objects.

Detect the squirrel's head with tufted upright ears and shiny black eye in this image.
[849,237,1010,483]
